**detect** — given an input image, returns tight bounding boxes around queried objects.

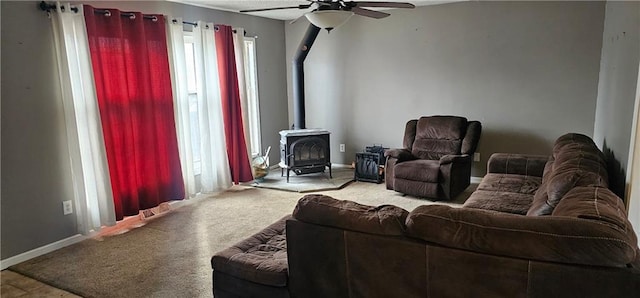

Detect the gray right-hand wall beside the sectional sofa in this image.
[593,1,640,197]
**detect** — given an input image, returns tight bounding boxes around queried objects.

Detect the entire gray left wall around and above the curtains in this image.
[0,1,288,259]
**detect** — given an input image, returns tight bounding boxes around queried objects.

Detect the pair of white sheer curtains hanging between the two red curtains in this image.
[167,18,232,196]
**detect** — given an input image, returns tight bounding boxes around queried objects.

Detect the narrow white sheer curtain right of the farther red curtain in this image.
[233,27,252,160]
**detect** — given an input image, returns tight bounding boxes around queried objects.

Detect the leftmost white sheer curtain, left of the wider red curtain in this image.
[51,2,116,235]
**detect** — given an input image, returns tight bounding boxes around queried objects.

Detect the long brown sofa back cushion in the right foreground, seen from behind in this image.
[407,205,636,267]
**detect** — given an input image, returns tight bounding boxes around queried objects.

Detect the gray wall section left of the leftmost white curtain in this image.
[0,1,76,259]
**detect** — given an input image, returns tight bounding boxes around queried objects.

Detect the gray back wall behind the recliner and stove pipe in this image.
[285,1,605,176]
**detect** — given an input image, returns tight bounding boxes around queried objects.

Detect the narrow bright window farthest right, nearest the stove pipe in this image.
[244,37,262,157]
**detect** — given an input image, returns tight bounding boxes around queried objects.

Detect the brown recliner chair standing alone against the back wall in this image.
[385,116,482,200]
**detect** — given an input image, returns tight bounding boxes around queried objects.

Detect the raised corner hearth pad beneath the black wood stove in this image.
[247,165,354,193]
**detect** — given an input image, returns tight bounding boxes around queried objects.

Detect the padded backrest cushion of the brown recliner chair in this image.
[411,116,467,159]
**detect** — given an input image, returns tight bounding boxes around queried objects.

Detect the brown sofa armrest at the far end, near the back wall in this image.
[487,153,549,177]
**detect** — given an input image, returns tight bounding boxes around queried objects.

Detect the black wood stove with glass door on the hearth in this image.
[280,129,332,182]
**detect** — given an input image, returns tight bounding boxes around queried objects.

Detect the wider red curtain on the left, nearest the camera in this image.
[84,5,184,220]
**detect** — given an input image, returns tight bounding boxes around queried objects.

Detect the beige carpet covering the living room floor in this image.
[9,182,476,297]
